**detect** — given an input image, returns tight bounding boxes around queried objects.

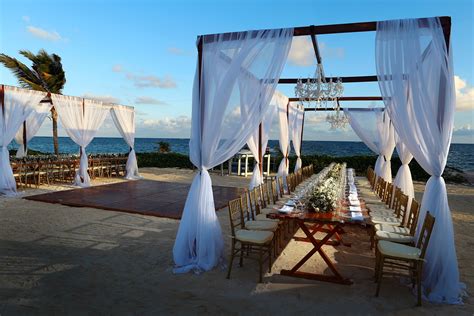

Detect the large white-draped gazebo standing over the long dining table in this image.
[173,17,461,303]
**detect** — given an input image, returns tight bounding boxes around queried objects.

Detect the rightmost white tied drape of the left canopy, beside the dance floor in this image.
[110,105,141,180]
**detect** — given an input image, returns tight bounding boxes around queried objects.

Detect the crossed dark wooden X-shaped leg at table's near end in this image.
[280,220,352,285]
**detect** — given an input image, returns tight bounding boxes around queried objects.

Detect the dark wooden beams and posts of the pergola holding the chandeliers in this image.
[198,16,451,173]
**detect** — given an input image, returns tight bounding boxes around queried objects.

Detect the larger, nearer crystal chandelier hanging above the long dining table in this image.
[295,63,344,111]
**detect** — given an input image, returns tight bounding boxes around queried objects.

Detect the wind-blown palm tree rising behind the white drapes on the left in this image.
[0,49,66,155]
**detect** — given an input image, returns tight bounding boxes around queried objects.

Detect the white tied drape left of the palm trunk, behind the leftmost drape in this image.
[15,102,53,158]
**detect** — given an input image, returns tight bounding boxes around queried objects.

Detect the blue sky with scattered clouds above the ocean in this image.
[0,0,474,143]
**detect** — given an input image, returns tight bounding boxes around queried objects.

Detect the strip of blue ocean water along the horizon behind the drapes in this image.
[8,136,474,171]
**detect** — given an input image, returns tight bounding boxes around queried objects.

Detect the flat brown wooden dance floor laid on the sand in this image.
[25,180,244,219]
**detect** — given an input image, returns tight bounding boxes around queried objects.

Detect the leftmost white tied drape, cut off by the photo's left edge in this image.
[0,85,46,196]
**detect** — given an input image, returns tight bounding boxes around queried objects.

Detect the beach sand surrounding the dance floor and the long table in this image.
[0,168,474,316]
